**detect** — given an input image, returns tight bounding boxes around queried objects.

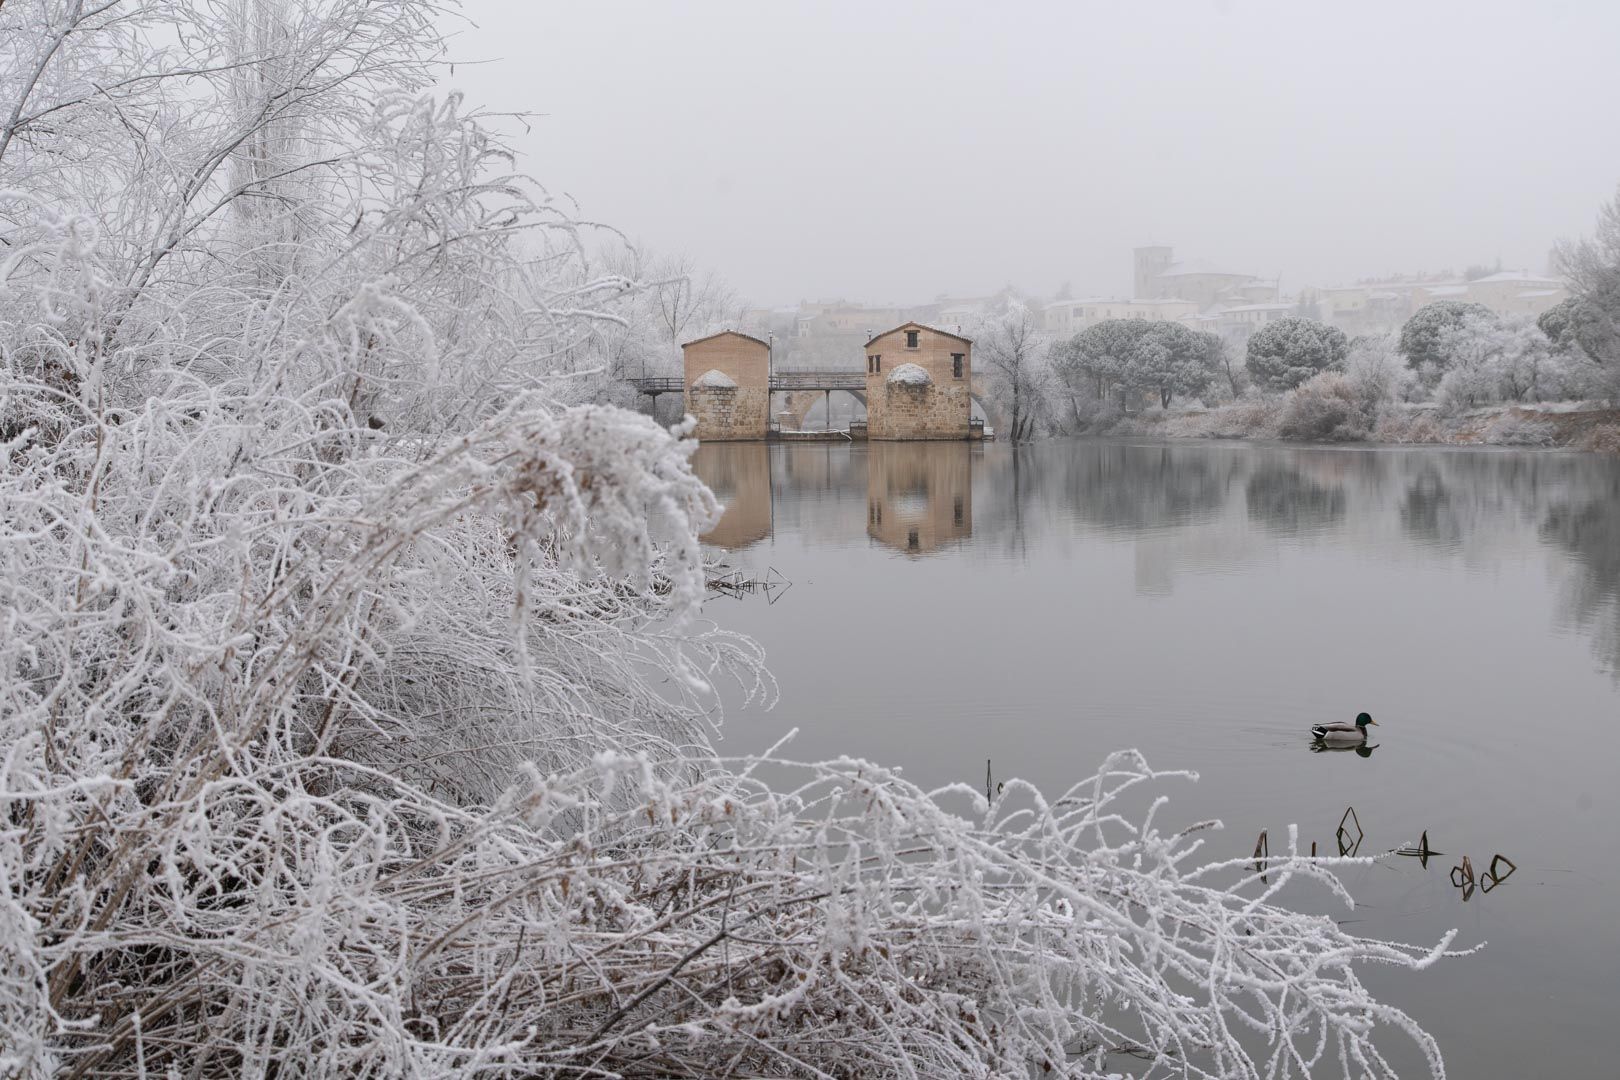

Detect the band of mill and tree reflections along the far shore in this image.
[695,442,1620,675]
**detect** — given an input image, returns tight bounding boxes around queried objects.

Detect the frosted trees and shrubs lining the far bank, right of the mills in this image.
[1050,194,1620,442]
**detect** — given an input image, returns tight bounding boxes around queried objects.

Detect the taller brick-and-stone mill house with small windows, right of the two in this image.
[867,324,974,439]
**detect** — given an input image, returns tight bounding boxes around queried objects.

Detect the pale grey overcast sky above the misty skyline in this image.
[452,0,1620,304]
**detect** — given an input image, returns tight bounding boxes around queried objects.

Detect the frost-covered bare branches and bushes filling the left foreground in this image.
[0,0,1470,1077]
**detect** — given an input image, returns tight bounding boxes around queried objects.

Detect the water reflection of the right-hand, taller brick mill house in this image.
[867,444,974,554]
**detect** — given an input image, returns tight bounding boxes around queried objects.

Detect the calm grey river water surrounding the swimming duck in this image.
[697,440,1620,1080]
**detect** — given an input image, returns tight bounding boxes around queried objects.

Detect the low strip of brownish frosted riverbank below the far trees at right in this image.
[1085,398,1620,453]
